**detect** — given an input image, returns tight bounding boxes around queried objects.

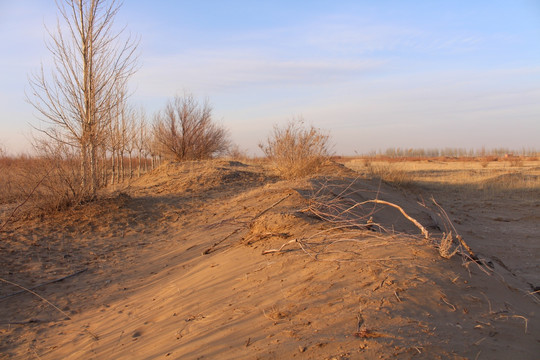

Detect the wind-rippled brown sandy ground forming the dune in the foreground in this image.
[0,161,540,359]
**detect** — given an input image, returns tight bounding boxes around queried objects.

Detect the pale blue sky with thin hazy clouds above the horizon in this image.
[0,0,540,155]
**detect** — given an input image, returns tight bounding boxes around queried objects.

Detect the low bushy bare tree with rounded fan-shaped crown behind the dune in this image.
[153,94,229,161]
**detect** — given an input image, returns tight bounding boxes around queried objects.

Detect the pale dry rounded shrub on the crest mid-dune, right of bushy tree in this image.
[259,118,330,179]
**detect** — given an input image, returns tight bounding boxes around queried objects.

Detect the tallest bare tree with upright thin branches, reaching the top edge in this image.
[27,0,138,196]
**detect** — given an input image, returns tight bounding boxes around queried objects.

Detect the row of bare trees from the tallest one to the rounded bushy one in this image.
[27,0,229,202]
